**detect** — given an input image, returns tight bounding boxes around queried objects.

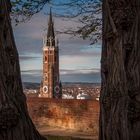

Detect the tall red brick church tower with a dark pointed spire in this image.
[39,10,62,98]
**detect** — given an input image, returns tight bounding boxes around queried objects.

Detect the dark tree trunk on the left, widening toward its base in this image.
[0,0,44,140]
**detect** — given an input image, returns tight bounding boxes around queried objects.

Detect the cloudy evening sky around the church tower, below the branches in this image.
[13,0,101,83]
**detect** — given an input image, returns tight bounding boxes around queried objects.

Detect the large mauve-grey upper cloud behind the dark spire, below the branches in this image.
[13,13,100,55]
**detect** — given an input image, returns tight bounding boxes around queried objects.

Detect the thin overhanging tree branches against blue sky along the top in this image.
[12,0,102,43]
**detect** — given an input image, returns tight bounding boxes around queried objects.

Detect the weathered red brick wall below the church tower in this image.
[27,97,99,134]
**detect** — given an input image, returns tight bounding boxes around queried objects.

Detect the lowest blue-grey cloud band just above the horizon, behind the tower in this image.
[22,70,101,83]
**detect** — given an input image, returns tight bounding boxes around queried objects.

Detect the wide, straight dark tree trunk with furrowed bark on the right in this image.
[100,0,140,140]
